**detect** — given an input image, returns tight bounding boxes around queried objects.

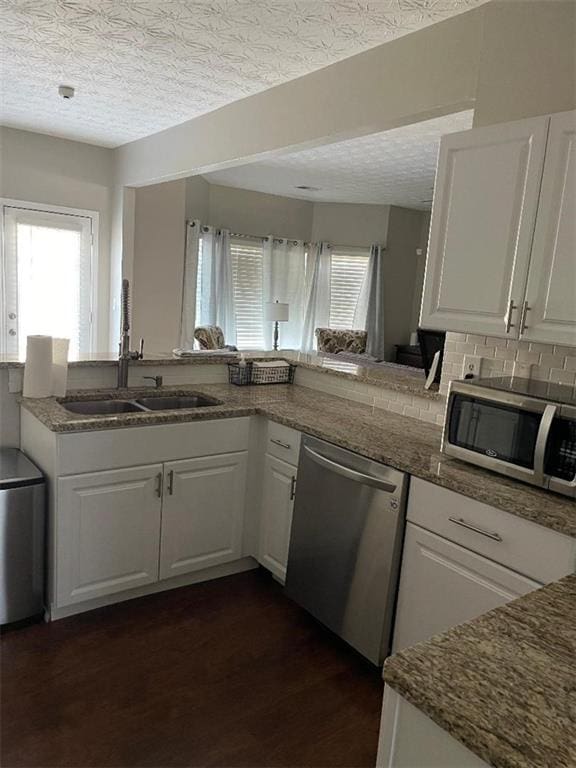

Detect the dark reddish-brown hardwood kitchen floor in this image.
[0,571,382,768]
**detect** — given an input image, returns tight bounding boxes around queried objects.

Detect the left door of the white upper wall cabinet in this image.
[420,117,549,338]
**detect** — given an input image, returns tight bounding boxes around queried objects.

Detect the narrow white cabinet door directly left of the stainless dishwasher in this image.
[260,454,296,581]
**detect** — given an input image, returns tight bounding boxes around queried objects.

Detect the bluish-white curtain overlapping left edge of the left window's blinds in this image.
[196,227,236,345]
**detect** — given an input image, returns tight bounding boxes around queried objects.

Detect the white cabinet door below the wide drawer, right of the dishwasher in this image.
[394,523,542,652]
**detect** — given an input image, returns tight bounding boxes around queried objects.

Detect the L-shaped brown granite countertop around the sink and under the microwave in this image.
[22,384,576,537]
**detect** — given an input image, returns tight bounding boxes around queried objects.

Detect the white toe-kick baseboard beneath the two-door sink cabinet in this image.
[46,557,258,621]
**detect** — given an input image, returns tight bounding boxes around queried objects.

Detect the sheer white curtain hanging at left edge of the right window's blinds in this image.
[300,242,331,352]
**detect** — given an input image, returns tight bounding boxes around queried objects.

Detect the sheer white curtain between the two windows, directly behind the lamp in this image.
[263,235,306,349]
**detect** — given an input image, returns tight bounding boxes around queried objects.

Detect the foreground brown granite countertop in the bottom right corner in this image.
[384,574,576,768]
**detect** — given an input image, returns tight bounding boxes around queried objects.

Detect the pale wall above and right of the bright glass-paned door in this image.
[0,128,114,351]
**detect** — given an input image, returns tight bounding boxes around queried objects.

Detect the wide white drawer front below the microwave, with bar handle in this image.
[408,478,576,584]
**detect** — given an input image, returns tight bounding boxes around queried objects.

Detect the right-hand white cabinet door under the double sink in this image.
[160,451,247,579]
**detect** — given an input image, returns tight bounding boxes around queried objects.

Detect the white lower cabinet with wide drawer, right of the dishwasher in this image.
[393,478,576,652]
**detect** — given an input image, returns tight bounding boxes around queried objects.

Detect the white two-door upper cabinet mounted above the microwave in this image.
[420,112,576,344]
